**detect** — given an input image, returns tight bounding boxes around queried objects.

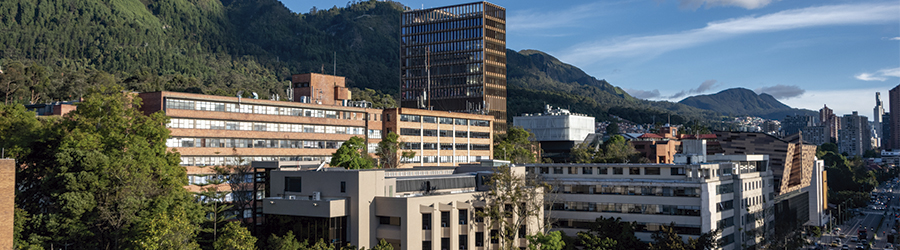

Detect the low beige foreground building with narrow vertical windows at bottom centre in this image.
[254,163,543,250]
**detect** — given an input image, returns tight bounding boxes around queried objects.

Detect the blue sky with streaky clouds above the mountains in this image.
[282,0,900,119]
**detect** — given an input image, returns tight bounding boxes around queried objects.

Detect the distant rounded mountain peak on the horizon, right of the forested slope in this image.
[678,88,818,120]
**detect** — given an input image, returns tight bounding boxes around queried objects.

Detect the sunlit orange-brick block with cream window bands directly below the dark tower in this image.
[382,108,494,167]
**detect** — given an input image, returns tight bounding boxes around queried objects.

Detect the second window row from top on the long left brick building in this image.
[166,118,366,135]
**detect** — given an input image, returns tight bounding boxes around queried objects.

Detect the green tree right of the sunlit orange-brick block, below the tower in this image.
[494,127,540,163]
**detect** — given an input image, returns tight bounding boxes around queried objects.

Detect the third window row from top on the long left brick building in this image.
[166,137,344,149]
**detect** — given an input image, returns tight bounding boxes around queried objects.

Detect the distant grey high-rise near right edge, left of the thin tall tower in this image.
[838,111,872,156]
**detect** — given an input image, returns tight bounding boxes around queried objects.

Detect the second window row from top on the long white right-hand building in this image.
[553,185,701,197]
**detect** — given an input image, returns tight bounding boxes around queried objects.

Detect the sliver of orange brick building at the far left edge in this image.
[0,159,16,249]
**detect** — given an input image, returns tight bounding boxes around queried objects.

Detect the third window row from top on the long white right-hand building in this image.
[546,201,700,216]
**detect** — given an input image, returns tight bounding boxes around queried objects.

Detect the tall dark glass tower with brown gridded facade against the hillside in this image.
[400,2,506,133]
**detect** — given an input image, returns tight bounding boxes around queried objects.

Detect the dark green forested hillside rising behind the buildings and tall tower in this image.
[0,0,716,123]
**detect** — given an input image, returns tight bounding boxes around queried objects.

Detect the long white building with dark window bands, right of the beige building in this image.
[526,140,774,249]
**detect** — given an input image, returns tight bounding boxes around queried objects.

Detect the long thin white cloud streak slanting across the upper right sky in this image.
[560,3,900,64]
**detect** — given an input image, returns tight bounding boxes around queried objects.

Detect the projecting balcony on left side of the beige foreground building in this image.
[262,196,347,218]
